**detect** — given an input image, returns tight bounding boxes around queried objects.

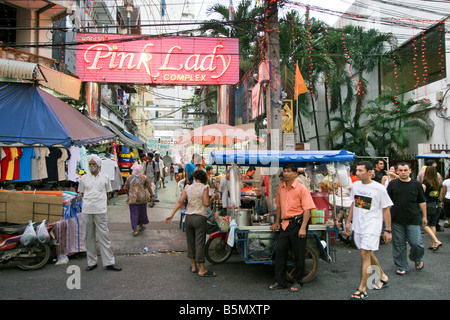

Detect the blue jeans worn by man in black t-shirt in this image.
[392,223,425,271]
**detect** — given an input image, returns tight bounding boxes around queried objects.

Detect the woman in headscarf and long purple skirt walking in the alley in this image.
[124,164,155,237]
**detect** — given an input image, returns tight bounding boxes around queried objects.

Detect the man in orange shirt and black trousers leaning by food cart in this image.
[269,163,316,292]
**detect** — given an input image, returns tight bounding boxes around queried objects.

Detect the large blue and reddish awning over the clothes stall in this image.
[0,83,116,147]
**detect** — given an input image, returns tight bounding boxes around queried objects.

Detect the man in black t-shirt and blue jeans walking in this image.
[387,162,427,276]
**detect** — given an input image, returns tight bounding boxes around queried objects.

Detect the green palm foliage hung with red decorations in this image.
[196,0,434,159]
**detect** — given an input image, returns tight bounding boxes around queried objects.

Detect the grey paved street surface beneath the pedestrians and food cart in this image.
[0,180,450,304]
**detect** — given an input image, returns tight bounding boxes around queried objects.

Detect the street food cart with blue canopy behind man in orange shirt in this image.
[206,150,355,283]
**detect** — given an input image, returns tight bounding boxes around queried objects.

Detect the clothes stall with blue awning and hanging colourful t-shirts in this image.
[0,83,116,264]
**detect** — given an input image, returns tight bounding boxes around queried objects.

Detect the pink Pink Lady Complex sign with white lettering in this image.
[77,34,239,85]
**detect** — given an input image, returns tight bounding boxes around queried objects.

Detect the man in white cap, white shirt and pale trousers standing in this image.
[78,155,122,271]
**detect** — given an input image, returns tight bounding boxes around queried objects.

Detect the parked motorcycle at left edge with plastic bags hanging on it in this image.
[0,223,57,270]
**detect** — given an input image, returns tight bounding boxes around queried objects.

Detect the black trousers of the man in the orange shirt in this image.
[275,221,308,287]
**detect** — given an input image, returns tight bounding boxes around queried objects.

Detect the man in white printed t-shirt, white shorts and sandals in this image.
[345,161,393,300]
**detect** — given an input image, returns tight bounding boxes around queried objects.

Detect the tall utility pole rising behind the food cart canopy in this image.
[264,0,283,209]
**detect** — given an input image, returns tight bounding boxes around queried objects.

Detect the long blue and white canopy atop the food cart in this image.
[209,150,355,167]
